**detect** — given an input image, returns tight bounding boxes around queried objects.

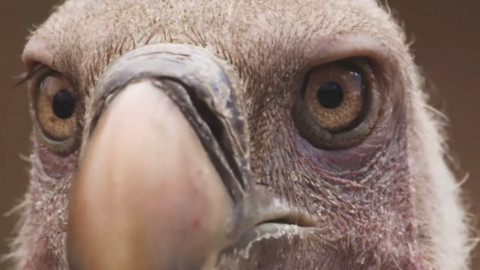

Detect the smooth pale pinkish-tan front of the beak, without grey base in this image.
[67,80,232,270]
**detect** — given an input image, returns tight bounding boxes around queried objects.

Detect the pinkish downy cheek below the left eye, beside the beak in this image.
[17,138,77,269]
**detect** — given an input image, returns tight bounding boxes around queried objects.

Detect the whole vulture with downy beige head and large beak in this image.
[7,0,472,270]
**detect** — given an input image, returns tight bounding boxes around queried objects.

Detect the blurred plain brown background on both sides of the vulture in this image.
[0,0,480,270]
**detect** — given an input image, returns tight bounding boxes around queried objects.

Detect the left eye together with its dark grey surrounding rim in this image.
[29,69,82,156]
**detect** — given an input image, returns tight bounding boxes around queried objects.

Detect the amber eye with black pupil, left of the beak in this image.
[35,72,78,152]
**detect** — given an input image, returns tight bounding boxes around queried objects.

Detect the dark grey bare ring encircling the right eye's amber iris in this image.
[291,58,380,150]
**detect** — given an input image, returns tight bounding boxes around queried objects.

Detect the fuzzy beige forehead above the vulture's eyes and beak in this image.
[27,0,404,92]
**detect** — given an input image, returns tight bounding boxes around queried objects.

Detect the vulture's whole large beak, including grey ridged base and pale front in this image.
[67,44,316,270]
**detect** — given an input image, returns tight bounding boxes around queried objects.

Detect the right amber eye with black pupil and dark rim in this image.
[292,59,378,149]
